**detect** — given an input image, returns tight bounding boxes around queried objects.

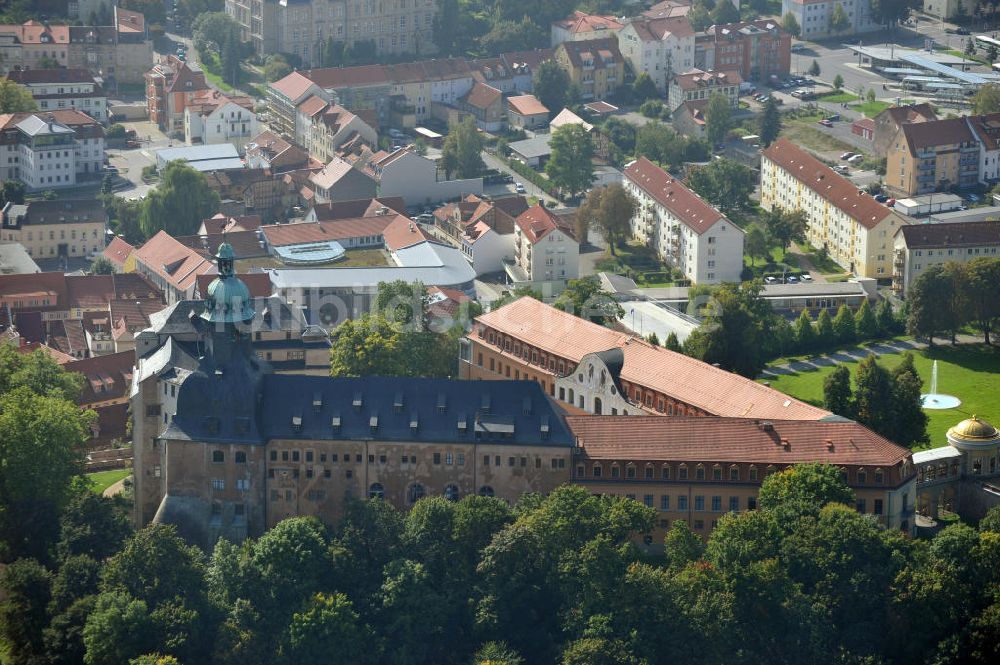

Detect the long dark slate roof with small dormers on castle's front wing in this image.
[259,374,573,447]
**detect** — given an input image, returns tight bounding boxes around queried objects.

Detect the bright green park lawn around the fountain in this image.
[769,344,1000,448]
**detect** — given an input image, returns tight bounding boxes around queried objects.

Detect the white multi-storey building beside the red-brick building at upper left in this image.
[184,90,260,153]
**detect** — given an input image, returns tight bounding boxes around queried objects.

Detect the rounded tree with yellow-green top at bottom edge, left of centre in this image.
[280,593,372,665]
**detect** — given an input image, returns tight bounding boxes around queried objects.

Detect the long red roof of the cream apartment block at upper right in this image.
[763,137,893,229]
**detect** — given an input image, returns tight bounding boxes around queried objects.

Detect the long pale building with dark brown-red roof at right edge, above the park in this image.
[892,220,1000,296]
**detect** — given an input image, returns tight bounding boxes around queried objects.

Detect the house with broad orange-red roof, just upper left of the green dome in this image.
[133,231,218,304]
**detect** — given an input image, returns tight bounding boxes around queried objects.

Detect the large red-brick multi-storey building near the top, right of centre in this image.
[694,19,792,81]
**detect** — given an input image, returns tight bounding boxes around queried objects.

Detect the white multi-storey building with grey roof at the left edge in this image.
[0,109,104,191]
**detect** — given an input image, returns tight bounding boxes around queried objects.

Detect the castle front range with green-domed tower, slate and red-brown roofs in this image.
[131,264,916,550]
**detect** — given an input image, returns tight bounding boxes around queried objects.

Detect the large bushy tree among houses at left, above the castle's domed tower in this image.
[139,161,219,238]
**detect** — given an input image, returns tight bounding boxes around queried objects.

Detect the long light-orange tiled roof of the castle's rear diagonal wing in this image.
[472,297,830,420]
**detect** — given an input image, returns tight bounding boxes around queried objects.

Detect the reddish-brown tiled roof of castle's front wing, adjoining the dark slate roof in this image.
[566,416,910,467]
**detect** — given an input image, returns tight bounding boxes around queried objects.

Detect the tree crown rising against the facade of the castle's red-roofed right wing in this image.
[758,463,854,515]
